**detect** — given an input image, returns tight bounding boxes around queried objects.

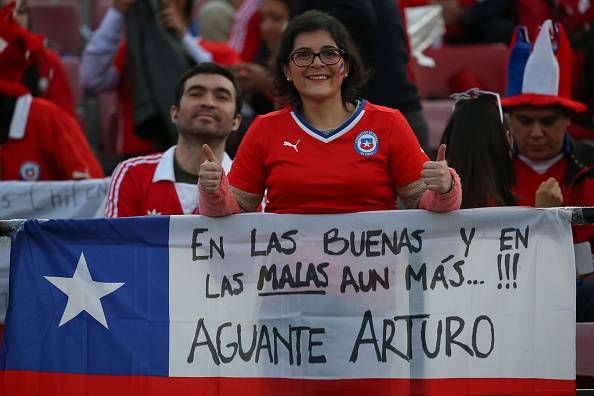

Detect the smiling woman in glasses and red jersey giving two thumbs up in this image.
[199,11,462,216]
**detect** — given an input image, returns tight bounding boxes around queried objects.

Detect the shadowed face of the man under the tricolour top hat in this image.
[509,106,570,161]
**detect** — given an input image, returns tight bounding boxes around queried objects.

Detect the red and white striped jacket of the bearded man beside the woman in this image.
[105,146,231,217]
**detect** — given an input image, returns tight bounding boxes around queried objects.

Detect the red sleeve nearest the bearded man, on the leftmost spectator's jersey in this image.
[39,101,105,180]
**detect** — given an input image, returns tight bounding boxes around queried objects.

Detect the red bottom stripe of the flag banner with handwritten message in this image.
[0,371,575,396]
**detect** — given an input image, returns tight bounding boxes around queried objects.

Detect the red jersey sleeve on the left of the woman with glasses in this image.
[229,117,266,194]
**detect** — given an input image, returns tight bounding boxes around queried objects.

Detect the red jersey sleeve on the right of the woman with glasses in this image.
[390,110,429,188]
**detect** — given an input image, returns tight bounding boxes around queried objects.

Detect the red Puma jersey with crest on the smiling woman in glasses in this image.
[229,101,428,213]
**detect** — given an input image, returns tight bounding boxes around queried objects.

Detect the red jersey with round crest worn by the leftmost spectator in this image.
[0,94,104,181]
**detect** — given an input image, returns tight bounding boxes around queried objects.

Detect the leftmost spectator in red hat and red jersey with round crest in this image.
[0,4,104,181]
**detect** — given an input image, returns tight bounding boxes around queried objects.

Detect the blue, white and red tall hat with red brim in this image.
[501,20,586,112]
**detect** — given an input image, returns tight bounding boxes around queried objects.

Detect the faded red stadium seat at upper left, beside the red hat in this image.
[29,3,81,56]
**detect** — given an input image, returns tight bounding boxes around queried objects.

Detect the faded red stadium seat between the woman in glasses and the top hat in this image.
[412,44,507,99]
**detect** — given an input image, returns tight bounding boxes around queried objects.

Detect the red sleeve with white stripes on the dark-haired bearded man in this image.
[105,159,143,217]
